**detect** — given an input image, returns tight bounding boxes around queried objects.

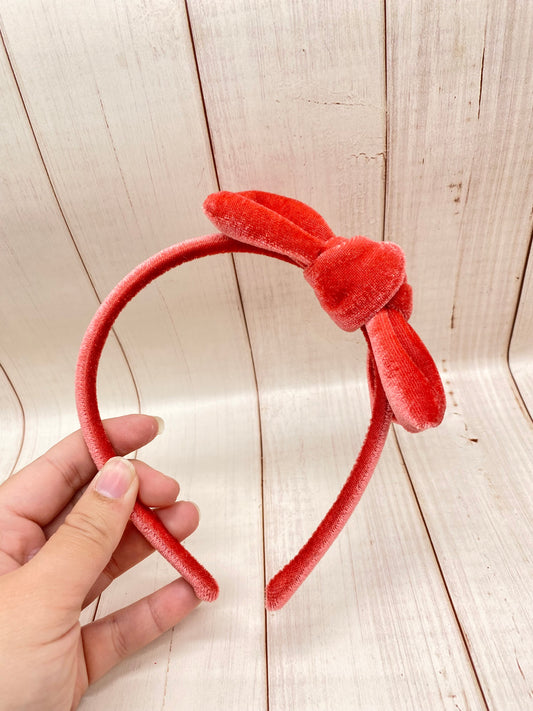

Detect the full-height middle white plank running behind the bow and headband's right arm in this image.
[190,1,483,710]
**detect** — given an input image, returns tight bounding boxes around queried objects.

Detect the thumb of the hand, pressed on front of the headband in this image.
[30,457,139,605]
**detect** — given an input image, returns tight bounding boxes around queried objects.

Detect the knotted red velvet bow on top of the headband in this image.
[204,191,445,432]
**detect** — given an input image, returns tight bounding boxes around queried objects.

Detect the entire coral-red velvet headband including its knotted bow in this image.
[76,191,445,610]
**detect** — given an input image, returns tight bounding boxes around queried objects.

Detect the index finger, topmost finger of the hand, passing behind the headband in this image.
[0,415,162,526]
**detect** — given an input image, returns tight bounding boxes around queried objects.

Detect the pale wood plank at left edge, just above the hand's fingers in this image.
[0,32,137,468]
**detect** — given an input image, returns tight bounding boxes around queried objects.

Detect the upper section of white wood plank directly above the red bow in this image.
[188,0,385,239]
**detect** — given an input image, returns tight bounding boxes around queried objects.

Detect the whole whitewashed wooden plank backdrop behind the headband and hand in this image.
[0,0,533,711]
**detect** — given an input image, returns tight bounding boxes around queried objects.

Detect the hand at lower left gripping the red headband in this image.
[0,415,199,711]
